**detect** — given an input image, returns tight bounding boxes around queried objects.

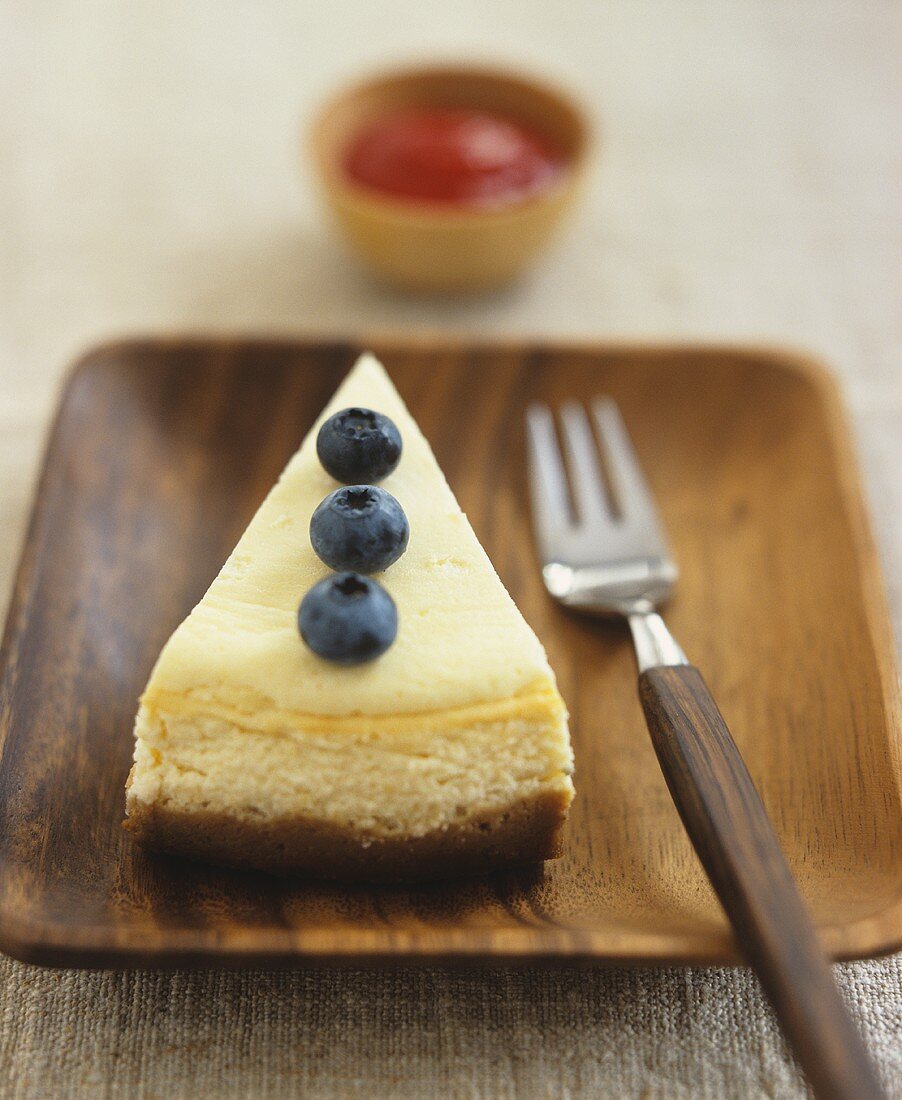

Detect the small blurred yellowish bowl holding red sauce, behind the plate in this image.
[312,65,589,292]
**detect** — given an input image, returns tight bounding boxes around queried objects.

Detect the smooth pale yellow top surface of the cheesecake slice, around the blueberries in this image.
[144,354,554,716]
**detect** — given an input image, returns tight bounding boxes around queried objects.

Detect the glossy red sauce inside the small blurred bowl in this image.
[344,107,564,208]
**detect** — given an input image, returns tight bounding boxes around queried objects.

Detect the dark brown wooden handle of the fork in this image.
[639,664,882,1100]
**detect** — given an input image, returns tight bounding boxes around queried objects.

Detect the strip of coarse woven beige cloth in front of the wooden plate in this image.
[0,957,902,1100]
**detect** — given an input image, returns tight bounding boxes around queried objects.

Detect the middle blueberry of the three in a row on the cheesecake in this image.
[310,485,410,573]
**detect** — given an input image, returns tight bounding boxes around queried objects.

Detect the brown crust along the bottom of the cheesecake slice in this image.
[123,789,570,883]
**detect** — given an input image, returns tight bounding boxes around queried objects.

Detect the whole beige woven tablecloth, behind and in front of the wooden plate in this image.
[0,0,902,1100]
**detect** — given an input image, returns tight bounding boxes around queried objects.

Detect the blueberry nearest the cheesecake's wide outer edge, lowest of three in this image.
[297,573,398,664]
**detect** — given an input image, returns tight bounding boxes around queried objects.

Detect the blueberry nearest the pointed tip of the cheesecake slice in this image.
[317,408,402,485]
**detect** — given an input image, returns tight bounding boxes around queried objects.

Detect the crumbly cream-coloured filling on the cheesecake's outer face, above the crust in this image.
[128,692,572,837]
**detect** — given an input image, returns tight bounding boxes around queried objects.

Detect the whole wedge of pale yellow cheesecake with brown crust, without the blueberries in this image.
[127,347,573,881]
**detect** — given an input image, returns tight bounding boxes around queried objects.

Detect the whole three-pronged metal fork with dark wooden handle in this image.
[527,398,882,1100]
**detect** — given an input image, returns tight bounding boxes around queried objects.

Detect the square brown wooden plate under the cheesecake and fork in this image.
[0,341,902,966]
